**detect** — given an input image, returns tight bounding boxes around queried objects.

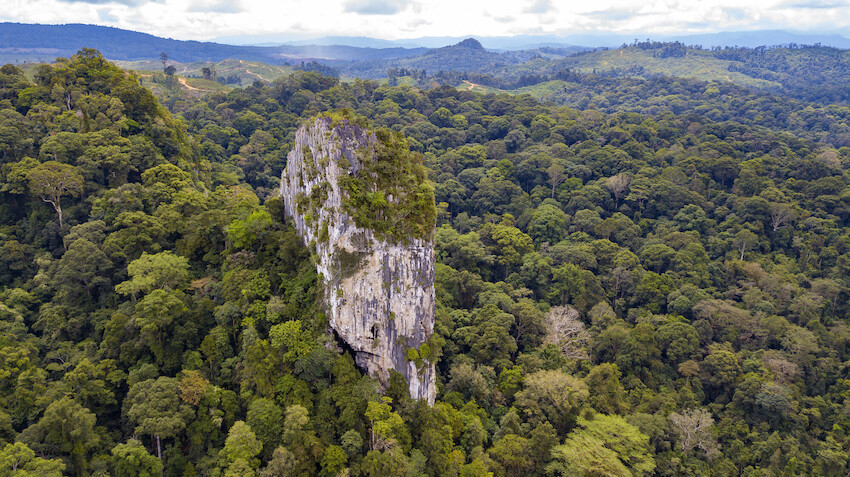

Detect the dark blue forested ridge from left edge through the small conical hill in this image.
[0,23,568,79]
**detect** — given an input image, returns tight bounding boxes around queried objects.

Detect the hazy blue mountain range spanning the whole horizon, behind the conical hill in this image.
[0,23,850,64]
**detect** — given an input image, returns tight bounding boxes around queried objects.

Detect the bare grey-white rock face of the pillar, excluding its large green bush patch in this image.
[280,117,436,404]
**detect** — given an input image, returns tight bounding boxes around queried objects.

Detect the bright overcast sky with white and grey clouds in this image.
[0,0,850,40]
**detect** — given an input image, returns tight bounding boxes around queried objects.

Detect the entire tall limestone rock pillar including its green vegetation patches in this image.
[280,115,436,404]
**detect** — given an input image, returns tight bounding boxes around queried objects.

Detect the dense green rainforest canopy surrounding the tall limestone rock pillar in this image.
[0,45,850,477]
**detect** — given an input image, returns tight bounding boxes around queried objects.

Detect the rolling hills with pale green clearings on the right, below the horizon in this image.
[342,39,850,104]
